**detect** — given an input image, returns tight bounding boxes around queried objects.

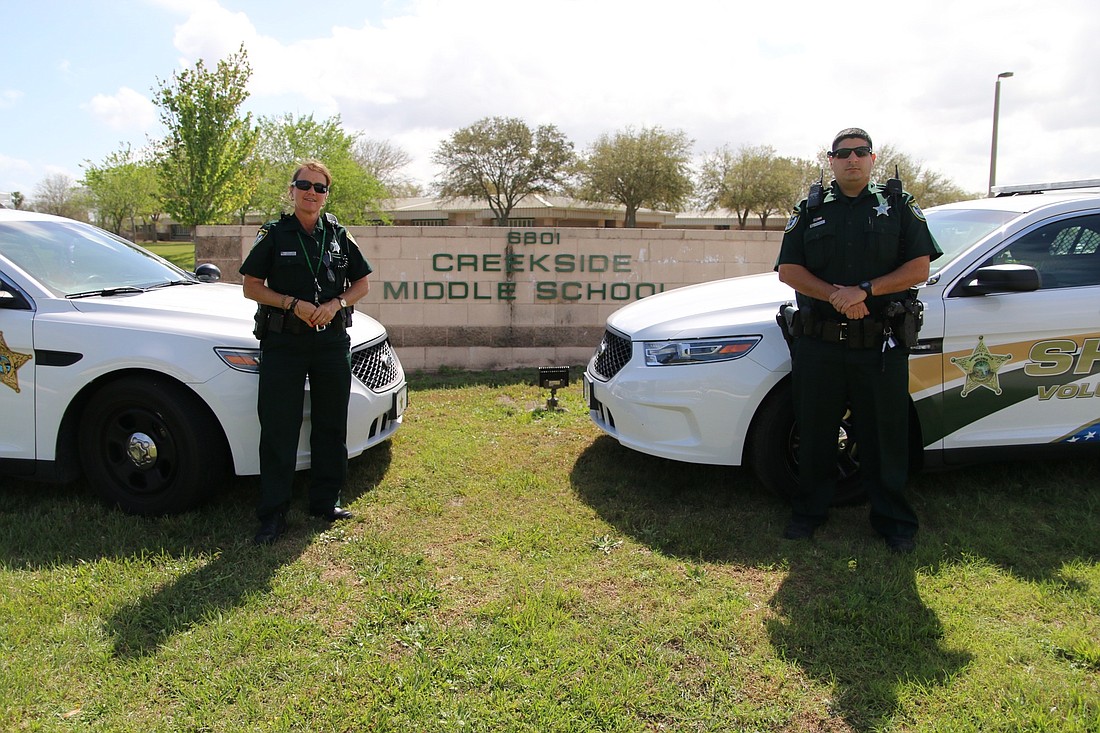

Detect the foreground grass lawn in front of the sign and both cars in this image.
[0,370,1100,733]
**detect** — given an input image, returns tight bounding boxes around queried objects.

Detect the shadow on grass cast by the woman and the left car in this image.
[0,442,391,658]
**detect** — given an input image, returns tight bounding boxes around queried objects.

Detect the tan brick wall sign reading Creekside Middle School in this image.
[195,227,782,371]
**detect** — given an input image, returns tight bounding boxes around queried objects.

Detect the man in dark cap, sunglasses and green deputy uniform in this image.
[777,128,942,553]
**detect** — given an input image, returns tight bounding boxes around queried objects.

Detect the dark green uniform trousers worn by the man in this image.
[792,337,917,537]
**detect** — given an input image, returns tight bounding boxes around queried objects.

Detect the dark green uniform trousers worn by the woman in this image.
[256,327,351,519]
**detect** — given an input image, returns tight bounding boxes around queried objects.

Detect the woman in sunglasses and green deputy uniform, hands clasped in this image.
[241,161,371,545]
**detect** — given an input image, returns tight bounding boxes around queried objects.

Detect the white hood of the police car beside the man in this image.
[607,272,794,341]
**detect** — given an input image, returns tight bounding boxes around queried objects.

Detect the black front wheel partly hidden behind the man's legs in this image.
[748,382,866,505]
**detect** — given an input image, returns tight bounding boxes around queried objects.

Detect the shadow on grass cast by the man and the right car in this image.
[571,436,1100,731]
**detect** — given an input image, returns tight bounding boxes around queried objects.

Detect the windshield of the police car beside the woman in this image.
[0,221,195,297]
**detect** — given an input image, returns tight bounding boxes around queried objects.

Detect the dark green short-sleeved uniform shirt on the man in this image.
[776,180,943,319]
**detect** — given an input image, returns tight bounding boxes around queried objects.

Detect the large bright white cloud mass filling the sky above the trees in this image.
[144,0,1100,192]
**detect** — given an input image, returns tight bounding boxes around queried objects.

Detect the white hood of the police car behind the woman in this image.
[69,283,385,348]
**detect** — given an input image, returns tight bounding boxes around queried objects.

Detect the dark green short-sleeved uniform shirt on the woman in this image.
[240,214,372,303]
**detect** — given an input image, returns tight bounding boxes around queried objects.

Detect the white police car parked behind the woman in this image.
[0,209,407,514]
